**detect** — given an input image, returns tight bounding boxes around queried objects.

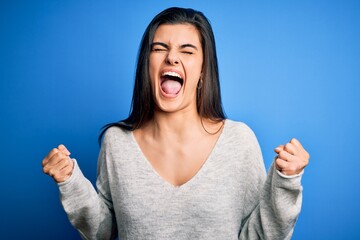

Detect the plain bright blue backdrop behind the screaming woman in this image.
[0,0,360,239]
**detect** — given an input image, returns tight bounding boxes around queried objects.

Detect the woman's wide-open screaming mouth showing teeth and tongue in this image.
[160,72,184,96]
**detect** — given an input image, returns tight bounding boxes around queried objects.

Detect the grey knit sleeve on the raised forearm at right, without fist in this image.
[239,158,302,240]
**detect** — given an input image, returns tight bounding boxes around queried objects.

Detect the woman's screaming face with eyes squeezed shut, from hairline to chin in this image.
[149,24,203,112]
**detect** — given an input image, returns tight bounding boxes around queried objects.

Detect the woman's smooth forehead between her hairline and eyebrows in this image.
[153,24,200,47]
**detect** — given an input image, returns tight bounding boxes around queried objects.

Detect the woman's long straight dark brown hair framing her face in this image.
[99,7,225,141]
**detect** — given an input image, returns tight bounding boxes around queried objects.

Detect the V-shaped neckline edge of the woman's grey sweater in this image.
[130,119,227,189]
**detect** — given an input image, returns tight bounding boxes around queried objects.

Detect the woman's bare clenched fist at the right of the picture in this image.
[274,138,310,176]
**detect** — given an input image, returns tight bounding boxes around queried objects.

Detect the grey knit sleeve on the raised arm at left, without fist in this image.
[58,134,117,239]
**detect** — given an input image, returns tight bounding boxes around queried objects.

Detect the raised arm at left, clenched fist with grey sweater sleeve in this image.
[43,142,117,239]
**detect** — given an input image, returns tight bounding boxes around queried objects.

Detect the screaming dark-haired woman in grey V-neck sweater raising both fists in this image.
[43,8,309,239]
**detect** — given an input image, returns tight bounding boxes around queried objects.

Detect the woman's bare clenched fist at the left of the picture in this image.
[42,144,74,183]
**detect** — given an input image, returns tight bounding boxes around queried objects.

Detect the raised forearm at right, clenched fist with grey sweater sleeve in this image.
[239,139,309,240]
